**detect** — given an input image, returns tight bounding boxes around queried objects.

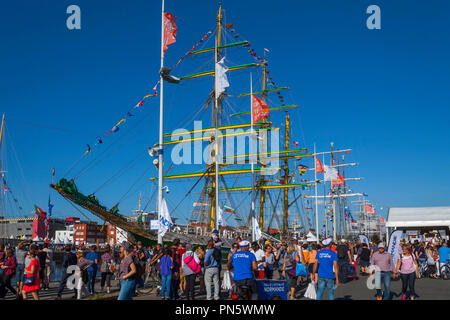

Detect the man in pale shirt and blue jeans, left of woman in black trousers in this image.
[370,242,396,300]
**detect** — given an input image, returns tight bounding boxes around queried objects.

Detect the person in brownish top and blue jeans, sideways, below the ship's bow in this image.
[117,241,137,300]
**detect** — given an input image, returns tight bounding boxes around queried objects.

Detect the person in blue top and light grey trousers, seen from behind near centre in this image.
[205,239,220,300]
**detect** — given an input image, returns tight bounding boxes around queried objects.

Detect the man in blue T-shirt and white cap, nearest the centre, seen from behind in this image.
[227,240,258,300]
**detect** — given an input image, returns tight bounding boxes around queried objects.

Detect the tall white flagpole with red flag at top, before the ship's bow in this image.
[158,0,164,244]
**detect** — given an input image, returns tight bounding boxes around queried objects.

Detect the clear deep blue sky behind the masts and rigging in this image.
[0,0,450,229]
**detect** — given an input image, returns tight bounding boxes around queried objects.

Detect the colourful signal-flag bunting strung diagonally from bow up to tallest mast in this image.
[78,31,212,155]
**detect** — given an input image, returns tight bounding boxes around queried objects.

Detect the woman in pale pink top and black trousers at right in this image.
[396,245,419,300]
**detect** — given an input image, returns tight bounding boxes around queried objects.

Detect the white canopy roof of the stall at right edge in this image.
[386,207,450,228]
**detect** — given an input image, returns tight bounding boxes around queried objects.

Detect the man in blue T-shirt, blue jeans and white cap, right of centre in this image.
[313,238,339,300]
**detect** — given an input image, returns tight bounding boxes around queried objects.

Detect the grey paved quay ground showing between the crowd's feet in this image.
[6,270,450,300]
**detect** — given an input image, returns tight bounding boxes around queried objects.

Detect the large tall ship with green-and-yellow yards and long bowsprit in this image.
[51,1,380,245]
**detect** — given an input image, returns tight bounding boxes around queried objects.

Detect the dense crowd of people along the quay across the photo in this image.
[0,230,450,300]
